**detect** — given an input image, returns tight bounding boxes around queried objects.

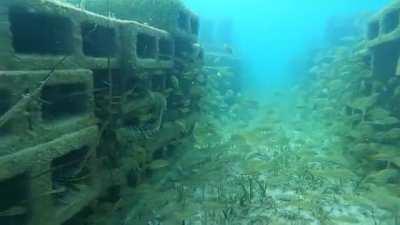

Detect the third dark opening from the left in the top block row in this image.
[136,34,157,58]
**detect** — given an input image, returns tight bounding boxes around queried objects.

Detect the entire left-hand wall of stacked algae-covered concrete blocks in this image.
[0,0,202,225]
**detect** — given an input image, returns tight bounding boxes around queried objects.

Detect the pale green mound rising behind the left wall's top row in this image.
[62,0,201,62]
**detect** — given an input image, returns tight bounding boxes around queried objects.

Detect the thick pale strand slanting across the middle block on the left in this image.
[0,55,68,127]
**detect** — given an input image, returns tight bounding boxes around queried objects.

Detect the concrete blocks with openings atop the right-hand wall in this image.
[367,1,400,79]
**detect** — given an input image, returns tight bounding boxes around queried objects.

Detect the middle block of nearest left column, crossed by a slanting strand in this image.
[0,70,96,156]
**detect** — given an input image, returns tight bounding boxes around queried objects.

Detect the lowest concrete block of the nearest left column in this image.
[0,126,99,225]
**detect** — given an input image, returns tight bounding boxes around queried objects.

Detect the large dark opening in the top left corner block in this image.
[9,7,74,55]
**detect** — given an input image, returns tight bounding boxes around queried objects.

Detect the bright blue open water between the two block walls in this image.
[186,0,389,94]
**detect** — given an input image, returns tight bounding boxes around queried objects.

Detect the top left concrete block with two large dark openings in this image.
[0,0,122,70]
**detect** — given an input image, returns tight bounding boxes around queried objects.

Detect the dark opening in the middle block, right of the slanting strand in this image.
[41,83,90,120]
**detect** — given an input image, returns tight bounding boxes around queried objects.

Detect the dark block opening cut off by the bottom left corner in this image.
[0,174,30,225]
